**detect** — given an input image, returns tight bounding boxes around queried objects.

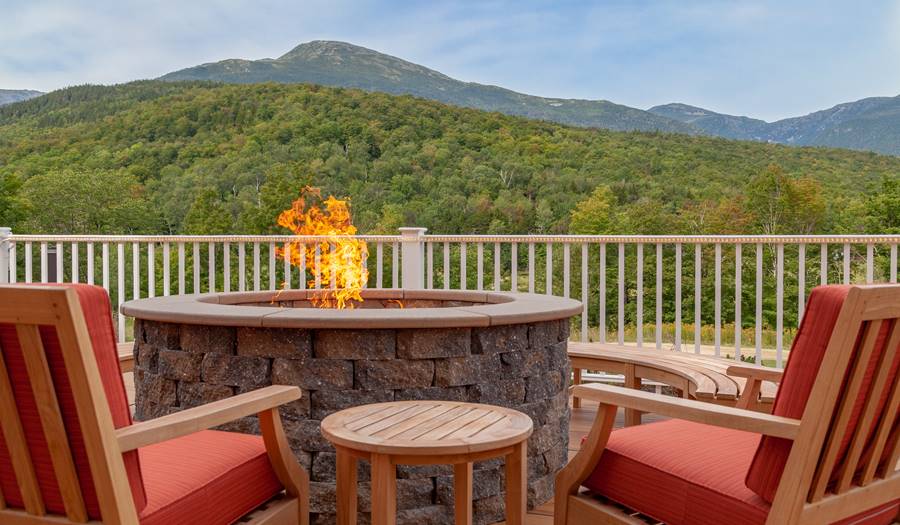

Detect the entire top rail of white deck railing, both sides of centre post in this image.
[8,234,900,244]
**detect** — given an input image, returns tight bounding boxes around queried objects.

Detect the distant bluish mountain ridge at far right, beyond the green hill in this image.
[648,96,900,155]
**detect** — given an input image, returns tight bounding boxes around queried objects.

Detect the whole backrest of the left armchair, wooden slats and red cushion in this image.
[0,285,145,522]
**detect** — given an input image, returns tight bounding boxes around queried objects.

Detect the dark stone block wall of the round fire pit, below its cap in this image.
[123,292,580,525]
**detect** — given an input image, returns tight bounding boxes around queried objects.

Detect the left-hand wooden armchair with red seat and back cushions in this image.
[0,285,309,525]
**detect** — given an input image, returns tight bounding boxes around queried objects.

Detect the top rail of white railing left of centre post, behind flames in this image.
[9,234,400,243]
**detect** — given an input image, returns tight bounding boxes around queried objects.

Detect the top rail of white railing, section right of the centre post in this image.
[425,235,900,244]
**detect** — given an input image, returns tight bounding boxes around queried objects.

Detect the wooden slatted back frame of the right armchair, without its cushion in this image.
[770,285,900,521]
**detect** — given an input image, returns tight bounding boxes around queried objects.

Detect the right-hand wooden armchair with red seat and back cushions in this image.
[554,285,900,525]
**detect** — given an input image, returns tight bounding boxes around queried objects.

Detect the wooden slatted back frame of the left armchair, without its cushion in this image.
[0,285,137,523]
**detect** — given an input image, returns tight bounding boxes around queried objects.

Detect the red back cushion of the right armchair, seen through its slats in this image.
[746,286,900,503]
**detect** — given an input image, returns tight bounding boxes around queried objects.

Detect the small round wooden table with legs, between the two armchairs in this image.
[322,401,532,525]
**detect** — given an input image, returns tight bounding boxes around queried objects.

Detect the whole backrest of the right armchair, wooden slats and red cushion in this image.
[747,285,900,523]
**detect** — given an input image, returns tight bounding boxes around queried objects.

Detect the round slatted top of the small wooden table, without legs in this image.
[322,401,532,455]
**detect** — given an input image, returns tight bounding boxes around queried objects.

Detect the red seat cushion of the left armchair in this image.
[140,430,282,525]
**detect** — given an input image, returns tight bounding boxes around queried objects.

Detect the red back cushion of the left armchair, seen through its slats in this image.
[0,284,146,519]
